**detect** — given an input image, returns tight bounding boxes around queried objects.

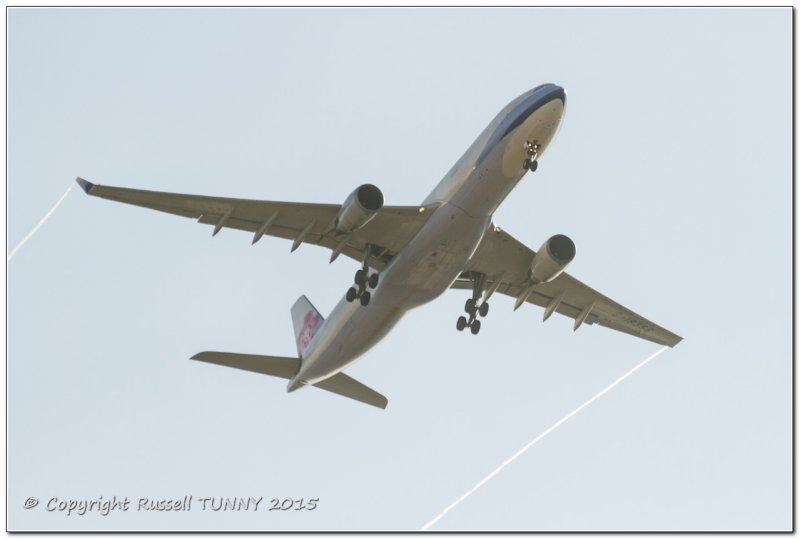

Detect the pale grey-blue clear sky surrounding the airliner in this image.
[7,8,792,530]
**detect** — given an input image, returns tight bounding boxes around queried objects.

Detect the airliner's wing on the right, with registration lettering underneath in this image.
[452,225,682,346]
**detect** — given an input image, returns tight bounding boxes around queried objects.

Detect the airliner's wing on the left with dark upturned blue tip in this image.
[77,178,431,270]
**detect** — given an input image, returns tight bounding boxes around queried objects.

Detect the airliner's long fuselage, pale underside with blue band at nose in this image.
[288,84,566,391]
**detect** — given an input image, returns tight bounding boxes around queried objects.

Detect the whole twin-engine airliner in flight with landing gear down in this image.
[77,84,682,408]
